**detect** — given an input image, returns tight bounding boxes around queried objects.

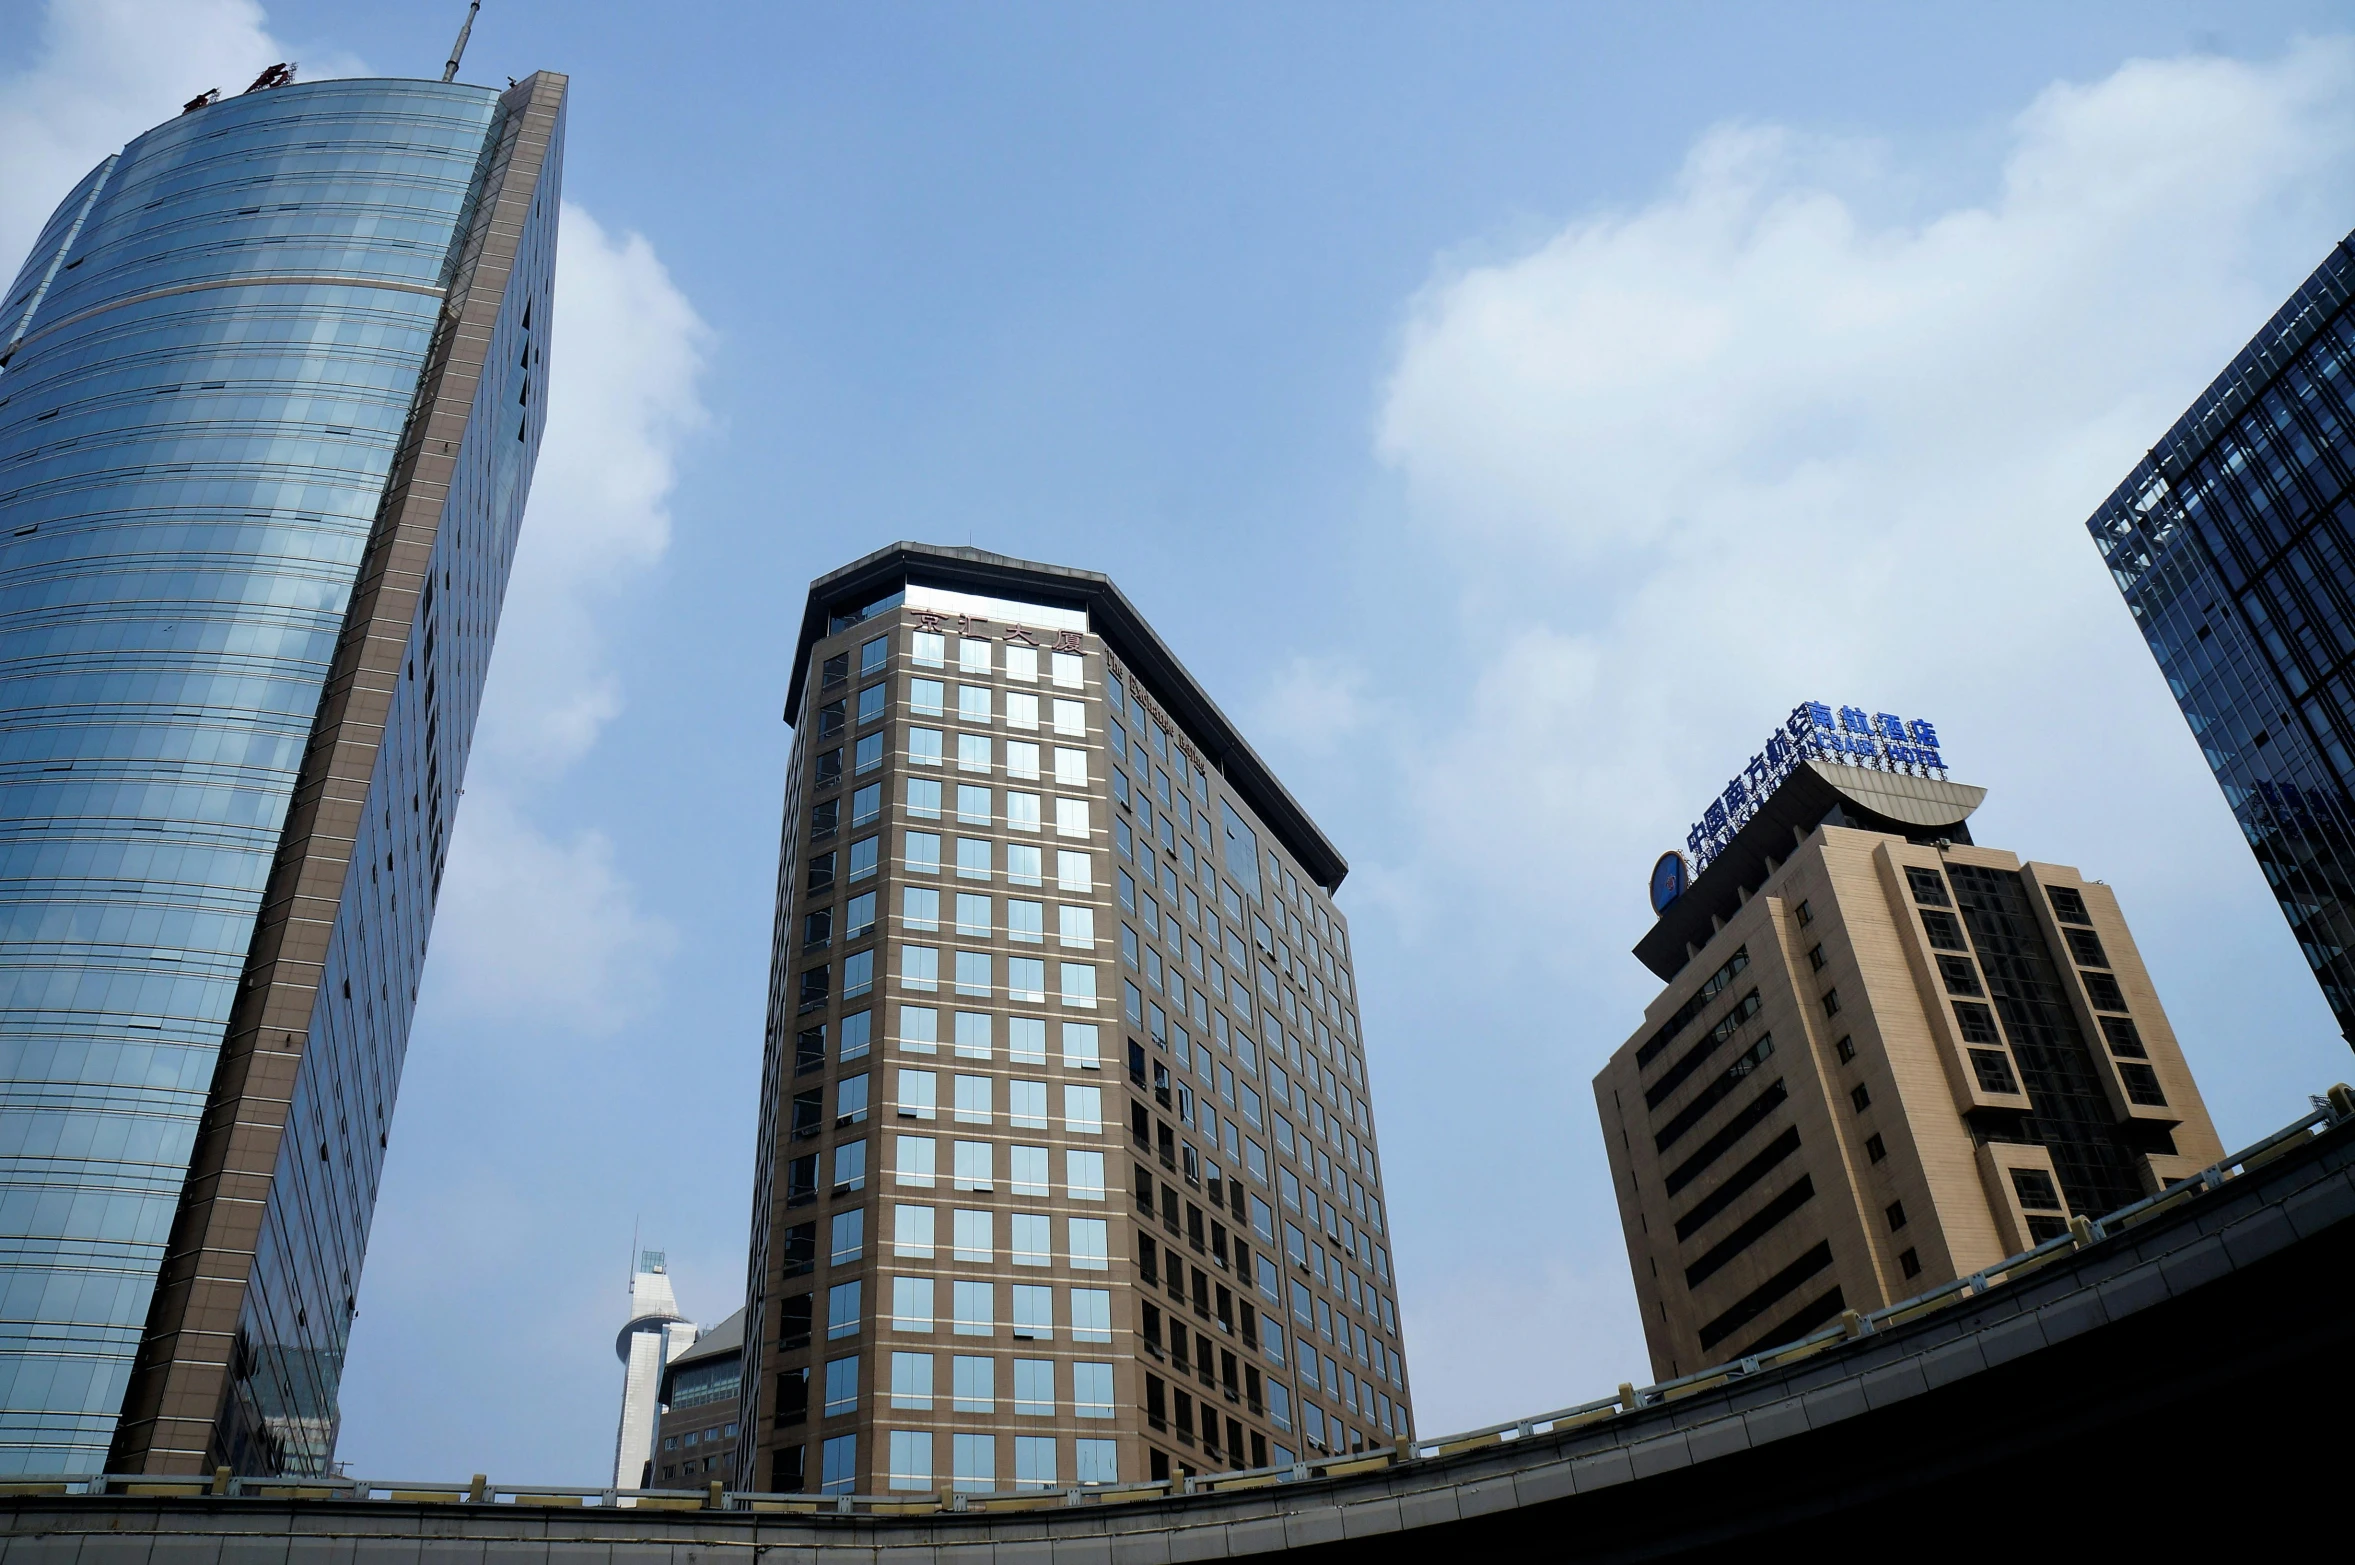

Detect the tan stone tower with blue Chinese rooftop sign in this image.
[1594,704,2223,1379]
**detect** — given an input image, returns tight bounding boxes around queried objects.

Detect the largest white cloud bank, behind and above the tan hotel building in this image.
[1356,40,2355,1431]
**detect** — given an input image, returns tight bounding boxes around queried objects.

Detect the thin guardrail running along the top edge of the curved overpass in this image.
[0,1083,2355,1516]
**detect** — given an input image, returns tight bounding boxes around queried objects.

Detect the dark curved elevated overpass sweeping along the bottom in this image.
[0,1087,2355,1565]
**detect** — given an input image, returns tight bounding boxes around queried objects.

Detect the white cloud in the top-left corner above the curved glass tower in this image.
[0,0,365,268]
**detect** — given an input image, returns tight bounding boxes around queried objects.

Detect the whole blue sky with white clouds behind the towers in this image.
[0,0,2355,1483]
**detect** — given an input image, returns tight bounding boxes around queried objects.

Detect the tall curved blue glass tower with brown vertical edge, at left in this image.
[0,68,565,1473]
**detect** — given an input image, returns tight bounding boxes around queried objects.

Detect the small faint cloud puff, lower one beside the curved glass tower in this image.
[433,784,678,1033]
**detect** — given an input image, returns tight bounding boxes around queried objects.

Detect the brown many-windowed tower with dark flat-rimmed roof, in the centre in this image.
[739,544,1411,1494]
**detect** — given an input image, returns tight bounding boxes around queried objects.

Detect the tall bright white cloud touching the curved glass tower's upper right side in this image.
[476,202,711,774]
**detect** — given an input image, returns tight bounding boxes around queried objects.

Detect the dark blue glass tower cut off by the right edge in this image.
[2087,229,2355,1043]
